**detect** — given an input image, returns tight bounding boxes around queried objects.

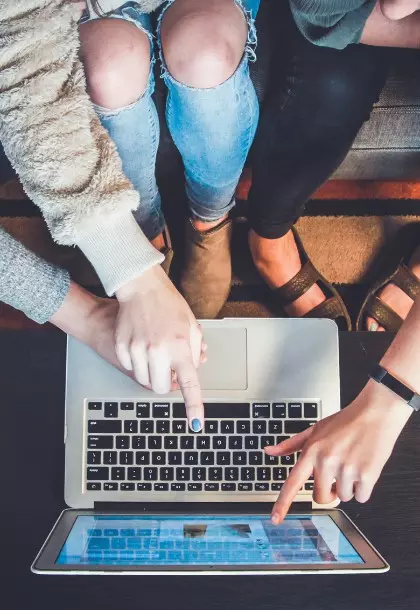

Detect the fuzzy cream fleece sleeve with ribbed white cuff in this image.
[0,0,163,294]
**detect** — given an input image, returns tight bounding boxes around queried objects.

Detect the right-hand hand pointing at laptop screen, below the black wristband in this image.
[266,381,413,524]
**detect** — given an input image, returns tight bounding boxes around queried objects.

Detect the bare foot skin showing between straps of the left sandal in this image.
[249,230,326,318]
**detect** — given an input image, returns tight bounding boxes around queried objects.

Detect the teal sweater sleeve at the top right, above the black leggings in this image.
[289,0,376,49]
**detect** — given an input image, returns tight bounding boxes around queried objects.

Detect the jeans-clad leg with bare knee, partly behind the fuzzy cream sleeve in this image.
[80,6,165,250]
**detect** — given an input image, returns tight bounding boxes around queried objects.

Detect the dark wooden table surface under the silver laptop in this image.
[4,330,420,610]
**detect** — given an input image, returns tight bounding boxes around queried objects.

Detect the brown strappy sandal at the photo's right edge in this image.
[356,223,420,332]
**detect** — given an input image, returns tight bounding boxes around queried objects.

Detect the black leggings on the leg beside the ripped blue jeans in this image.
[249,3,388,239]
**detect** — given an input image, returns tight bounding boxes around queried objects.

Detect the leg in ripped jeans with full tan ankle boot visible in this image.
[160,0,259,317]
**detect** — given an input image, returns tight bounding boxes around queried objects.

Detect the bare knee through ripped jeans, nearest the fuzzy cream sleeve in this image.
[80,19,150,109]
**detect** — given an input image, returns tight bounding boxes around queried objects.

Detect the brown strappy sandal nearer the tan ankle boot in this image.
[273,227,352,330]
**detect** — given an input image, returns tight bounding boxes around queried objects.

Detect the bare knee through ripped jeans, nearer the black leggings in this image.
[162,0,248,89]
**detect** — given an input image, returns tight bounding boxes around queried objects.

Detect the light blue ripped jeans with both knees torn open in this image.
[81,0,260,239]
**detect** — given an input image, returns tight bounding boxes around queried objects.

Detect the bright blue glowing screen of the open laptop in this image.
[56,514,364,566]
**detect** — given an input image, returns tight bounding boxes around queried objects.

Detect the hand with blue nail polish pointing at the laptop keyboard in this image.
[115,265,205,432]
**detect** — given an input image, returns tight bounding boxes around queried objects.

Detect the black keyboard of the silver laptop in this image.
[85,400,320,493]
